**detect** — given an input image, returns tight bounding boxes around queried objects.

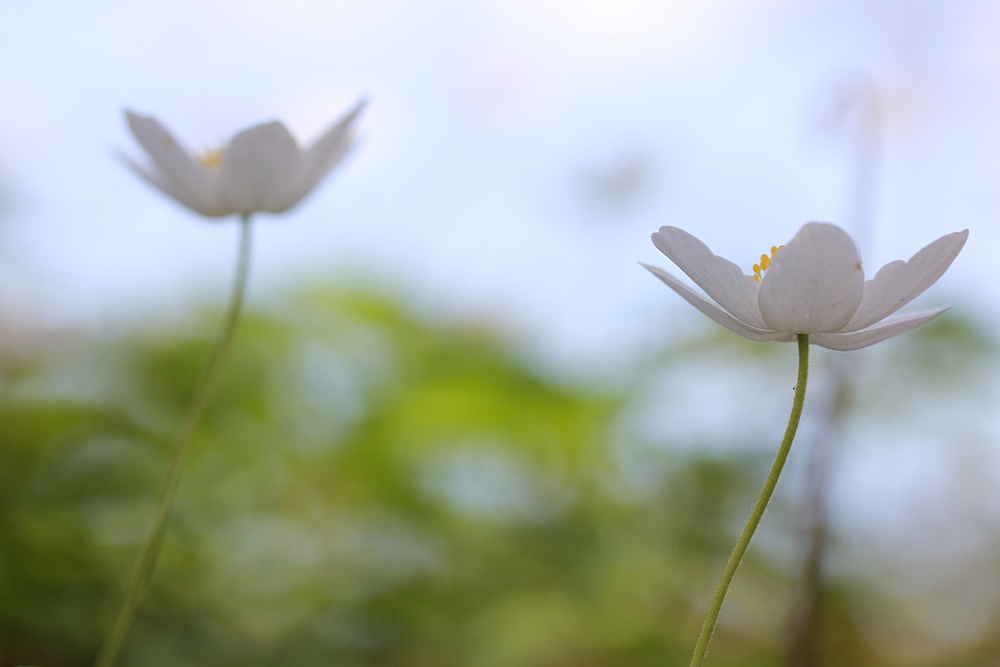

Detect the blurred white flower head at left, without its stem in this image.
[122,100,365,217]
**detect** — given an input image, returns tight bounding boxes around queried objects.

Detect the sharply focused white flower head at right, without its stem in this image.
[646,222,969,350]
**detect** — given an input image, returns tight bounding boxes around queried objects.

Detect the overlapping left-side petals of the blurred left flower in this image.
[125,109,223,217]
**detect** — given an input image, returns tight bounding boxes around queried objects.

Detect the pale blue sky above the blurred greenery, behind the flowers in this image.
[0,0,1000,370]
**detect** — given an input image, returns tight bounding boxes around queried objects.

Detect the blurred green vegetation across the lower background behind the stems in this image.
[0,290,1000,667]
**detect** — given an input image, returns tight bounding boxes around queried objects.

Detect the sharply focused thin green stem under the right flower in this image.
[691,334,809,667]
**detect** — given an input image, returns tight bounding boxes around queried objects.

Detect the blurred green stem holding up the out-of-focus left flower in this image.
[95,215,250,667]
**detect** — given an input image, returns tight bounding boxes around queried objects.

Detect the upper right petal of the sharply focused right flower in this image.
[843,229,969,332]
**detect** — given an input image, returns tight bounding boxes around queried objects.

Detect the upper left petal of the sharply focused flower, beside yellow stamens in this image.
[653,227,767,329]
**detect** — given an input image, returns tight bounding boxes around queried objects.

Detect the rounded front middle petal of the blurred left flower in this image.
[218,122,304,214]
